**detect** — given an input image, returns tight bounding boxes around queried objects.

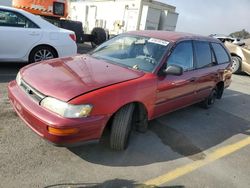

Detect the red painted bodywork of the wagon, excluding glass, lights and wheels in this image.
[8,31,231,144]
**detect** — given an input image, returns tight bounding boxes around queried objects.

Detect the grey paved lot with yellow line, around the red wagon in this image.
[0,46,250,188]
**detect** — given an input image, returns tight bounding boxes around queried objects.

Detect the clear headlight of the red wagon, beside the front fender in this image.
[41,97,93,118]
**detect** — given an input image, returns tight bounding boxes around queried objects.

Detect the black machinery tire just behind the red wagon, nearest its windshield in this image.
[91,27,107,48]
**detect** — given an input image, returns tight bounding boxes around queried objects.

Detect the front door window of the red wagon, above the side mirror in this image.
[167,41,193,71]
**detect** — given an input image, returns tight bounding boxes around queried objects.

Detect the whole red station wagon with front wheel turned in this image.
[8,31,232,150]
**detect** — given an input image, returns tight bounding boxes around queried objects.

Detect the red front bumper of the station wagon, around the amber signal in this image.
[8,81,109,146]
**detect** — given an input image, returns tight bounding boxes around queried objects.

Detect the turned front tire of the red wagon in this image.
[110,104,135,151]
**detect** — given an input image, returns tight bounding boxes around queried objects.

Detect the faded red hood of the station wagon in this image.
[21,55,144,101]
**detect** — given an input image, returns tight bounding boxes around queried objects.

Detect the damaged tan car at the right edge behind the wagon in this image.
[225,42,250,75]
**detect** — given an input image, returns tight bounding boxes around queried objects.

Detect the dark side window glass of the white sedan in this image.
[0,10,38,28]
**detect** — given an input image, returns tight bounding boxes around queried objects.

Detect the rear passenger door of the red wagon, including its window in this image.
[194,40,219,100]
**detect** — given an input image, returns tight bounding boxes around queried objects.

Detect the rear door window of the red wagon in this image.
[194,41,213,68]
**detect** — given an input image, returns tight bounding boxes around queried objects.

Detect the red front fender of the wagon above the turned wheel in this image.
[69,73,157,119]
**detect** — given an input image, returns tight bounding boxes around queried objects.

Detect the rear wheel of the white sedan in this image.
[29,46,58,63]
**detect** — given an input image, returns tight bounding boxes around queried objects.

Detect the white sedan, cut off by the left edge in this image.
[0,6,77,62]
